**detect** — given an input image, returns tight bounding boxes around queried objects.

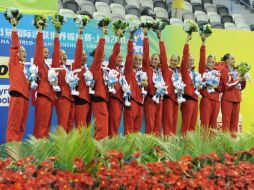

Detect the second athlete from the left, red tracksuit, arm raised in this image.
[34,23,56,138]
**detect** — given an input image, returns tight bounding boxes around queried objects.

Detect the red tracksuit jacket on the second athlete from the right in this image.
[198,46,222,102]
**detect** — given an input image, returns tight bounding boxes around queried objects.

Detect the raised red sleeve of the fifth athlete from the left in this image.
[91,38,105,73]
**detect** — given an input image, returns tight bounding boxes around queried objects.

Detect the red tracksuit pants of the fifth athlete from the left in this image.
[92,101,108,140]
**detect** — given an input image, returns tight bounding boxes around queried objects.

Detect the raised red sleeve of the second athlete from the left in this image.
[34,32,44,70]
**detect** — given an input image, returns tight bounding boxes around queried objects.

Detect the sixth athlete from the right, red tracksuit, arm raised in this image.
[124,34,147,135]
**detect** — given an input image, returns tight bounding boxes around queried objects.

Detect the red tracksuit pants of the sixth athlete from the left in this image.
[108,97,123,137]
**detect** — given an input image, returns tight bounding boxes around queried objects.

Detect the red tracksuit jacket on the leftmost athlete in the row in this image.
[9,31,30,99]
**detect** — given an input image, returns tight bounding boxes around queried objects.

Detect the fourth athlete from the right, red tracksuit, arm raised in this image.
[160,37,180,135]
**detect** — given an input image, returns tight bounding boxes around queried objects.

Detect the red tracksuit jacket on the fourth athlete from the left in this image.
[72,39,91,102]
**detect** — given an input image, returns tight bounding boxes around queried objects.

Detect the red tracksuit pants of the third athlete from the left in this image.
[56,96,75,132]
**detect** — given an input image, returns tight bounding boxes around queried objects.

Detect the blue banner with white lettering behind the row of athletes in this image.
[0,13,147,144]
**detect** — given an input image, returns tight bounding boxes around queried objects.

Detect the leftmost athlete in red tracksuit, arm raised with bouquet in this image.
[6,19,30,142]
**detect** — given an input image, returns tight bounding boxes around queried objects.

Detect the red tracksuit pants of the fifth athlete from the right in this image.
[144,96,162,136]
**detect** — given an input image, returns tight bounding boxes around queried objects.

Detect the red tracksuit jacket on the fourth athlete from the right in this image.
[159,42,177,102]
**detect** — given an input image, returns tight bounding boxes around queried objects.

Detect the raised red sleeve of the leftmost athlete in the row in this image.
[9,31,20,65]
